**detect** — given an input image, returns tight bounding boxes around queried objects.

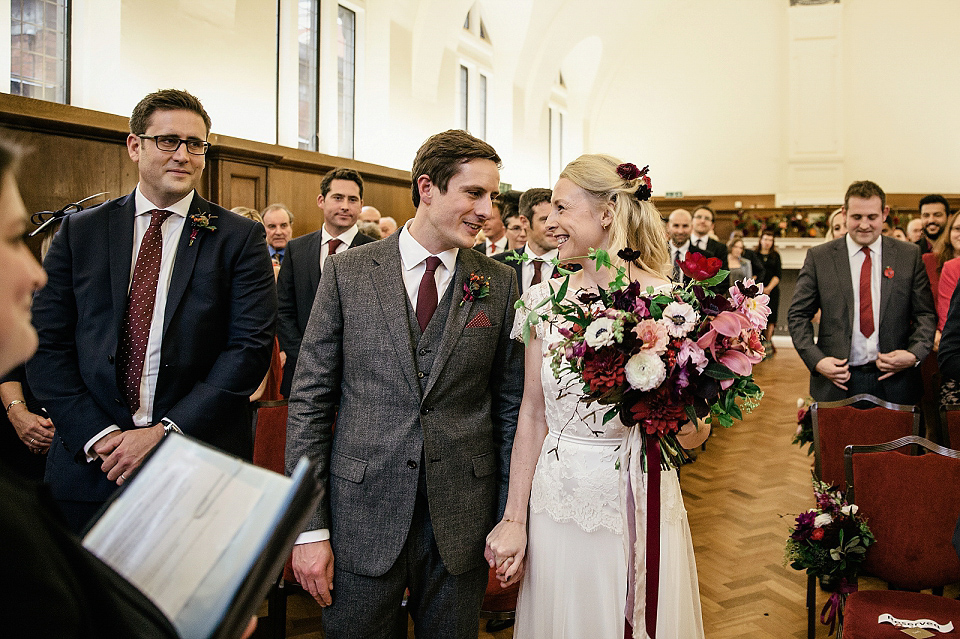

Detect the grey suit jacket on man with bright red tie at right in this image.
[787,236,937,404]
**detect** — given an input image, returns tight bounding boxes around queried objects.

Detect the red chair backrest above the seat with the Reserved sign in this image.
[844,436,960,590]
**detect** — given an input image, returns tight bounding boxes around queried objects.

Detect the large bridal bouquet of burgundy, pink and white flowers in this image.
[517,249,770,469]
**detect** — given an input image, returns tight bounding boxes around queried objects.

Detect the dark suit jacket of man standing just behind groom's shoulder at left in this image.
[277,231,374,397]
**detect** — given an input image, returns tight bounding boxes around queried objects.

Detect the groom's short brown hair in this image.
[410,129,500,207]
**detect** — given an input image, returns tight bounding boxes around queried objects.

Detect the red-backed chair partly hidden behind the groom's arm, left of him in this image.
[253,399,296,639]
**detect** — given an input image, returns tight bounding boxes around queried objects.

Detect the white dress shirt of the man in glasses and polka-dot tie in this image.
[83,185,196,461]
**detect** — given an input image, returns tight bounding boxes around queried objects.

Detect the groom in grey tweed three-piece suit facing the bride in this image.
[287,130,523,639]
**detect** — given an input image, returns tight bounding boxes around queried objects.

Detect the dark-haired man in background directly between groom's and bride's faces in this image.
[493,188,557,294]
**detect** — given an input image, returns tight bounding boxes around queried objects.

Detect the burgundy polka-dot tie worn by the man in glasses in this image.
[117,209,173,413]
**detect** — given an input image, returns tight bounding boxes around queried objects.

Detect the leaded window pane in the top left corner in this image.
[10,0,68,103]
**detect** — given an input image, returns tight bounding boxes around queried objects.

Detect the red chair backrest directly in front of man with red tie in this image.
[811,394,920,489]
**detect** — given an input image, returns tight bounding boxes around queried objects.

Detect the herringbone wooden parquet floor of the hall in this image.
[262,348,872,639]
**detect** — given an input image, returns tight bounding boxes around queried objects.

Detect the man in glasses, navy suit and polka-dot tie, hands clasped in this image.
[27,90,276,530]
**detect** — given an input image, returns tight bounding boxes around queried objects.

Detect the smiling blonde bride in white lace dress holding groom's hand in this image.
[487,155,709,639]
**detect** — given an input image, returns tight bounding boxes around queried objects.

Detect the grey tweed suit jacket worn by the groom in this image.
[286,233,523,576]
